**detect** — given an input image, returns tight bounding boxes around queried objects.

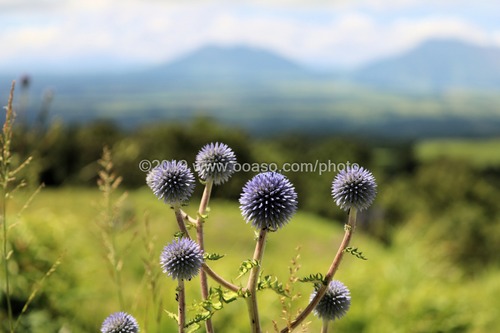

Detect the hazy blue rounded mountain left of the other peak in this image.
[143,45,310,82]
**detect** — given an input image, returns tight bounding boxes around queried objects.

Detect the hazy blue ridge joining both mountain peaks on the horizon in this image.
[135,39,500,92]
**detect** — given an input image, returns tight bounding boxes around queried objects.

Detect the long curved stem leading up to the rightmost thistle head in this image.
[280,207,357,333]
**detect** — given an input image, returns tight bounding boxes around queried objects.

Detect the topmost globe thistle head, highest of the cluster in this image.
[195,142,236,185]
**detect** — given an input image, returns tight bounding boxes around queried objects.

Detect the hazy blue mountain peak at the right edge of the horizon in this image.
[352,40,500,91]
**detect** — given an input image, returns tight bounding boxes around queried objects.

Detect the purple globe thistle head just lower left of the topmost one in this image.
[146,160,195,206]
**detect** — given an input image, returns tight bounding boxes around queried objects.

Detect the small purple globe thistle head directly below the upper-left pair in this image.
[160,237,203,280]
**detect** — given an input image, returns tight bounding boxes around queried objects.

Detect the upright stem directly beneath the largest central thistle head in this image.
[245,228,267,333]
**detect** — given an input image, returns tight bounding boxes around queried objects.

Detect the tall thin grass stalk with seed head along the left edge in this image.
[0,81,15,333]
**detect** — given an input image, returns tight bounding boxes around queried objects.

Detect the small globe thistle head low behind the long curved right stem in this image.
[310,280,351,320]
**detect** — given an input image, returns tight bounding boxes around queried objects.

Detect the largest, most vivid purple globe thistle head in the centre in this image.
[240,172,297,230]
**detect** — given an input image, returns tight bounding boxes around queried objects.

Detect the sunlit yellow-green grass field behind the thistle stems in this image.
[2,188,500,333]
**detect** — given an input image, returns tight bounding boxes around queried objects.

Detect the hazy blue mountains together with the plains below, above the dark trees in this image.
[0,40,500,137]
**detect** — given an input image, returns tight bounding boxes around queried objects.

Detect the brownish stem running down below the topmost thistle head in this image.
[196,180,214,333]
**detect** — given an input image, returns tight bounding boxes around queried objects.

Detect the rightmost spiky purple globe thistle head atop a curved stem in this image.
[332,167,377,211]
